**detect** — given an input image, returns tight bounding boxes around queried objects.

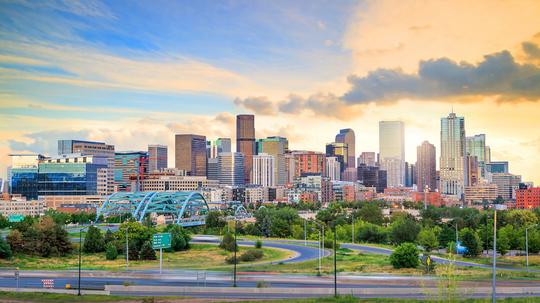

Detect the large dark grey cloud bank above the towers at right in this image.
[343,51,540,104]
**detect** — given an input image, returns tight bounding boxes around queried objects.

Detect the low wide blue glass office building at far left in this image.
[38,154,108,196]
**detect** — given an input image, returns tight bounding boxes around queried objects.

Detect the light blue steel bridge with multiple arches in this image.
[97,191,209,227]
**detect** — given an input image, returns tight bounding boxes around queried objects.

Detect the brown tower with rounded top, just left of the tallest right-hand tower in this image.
[416,141,437,191]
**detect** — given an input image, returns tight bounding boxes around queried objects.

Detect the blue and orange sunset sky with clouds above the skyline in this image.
[0,0,540,185]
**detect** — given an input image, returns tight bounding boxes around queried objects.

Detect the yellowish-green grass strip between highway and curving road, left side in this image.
[0,244,292,271]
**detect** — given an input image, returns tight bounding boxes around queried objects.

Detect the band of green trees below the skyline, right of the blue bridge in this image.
[205,201,540,257]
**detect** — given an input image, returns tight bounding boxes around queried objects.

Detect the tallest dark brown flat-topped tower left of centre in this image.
[236,115,255,184]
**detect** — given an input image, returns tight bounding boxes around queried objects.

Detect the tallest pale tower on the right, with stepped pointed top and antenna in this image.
[439,113,467,198]
